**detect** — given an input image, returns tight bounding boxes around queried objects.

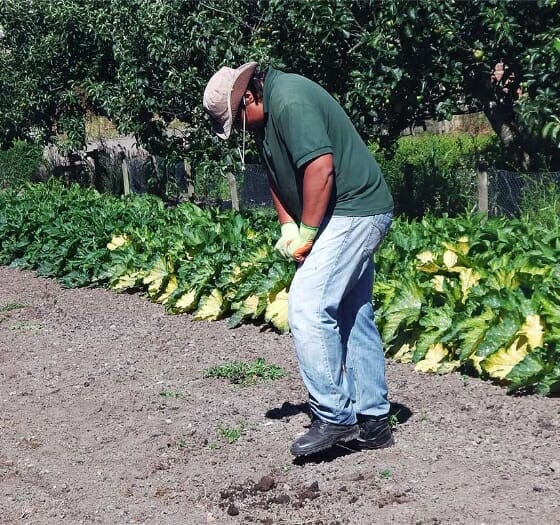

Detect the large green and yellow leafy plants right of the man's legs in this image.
[374,216,560,394]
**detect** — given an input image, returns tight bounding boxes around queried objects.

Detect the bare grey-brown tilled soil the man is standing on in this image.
[0,267,560,525]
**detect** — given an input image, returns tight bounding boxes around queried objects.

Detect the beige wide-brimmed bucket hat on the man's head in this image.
[203,62,257,139]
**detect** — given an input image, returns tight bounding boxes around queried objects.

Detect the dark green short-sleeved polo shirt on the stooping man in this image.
[257,68,393,221]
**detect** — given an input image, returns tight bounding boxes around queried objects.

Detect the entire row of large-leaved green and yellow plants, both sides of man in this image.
[0,181,560,395]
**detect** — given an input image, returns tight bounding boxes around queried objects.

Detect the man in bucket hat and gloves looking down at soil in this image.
[204,62,393,456]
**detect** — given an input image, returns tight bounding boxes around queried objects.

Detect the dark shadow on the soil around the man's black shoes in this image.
[265,401,412,465]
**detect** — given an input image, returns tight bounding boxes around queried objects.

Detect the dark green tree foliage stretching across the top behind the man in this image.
[0,0,560,176]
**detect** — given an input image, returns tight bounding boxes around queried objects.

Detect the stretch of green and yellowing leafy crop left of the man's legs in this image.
[0,181,294,330]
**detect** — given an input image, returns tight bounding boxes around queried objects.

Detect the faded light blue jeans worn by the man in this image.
[288,213,392,425]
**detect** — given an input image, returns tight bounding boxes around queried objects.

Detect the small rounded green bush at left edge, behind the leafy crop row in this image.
[0,140,43,190]
